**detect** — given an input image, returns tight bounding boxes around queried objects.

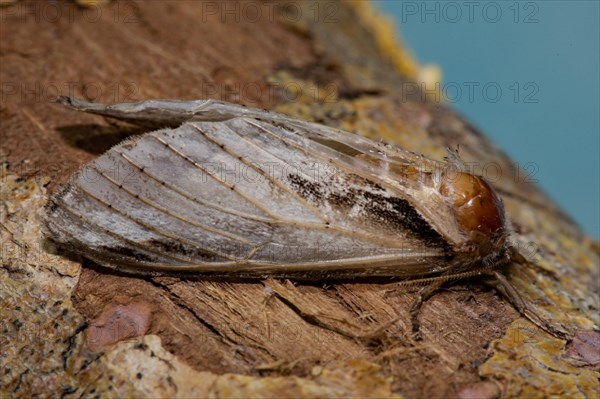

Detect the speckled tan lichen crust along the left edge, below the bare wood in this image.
[0,170,84,397]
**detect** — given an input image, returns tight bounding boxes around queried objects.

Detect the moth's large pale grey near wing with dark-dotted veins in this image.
[46,118,445,275]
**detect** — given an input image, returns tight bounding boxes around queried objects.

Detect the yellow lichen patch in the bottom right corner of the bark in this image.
[479,319,600,398]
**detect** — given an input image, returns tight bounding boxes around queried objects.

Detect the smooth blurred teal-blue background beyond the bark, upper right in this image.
[376,0,600,240]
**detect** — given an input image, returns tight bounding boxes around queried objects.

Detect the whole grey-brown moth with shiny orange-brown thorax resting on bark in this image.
[45,97,556,340]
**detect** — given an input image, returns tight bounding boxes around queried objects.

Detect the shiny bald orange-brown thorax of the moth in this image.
[440,172,506,253]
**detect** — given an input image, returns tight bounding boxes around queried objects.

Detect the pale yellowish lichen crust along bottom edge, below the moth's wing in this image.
[83,335,401,399]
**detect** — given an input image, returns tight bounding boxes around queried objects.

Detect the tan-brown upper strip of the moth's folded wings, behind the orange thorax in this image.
[239,114,466,246]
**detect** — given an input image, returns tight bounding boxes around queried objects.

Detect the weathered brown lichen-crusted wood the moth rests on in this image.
[0,1,600,398]
